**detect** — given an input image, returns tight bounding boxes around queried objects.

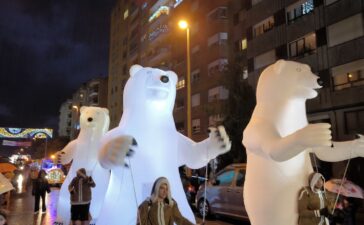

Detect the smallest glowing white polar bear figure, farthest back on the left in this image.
[56,106,110,225]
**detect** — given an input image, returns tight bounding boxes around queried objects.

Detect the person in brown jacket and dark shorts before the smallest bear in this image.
[68,168,96,225]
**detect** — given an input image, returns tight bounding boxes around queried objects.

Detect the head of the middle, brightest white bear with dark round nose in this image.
[123,65,177,113]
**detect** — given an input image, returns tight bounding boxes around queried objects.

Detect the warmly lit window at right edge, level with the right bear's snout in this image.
[332,59,364,91]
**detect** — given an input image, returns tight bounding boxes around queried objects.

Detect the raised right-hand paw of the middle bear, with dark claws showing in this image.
[207,126,231,160]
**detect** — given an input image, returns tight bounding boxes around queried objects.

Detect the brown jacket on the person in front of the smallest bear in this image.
[68,176,96,205]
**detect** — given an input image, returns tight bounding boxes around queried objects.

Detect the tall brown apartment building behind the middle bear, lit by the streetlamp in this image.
[109,0,229,140]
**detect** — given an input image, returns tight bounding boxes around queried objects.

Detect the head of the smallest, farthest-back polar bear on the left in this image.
[80,106,110,133]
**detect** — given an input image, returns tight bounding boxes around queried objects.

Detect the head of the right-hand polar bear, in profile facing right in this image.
[257,60,321,103]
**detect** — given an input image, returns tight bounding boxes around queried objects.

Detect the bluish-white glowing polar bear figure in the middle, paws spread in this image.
[97,65,231,225]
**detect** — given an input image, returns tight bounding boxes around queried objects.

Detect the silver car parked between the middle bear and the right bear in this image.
[196,163,248,220]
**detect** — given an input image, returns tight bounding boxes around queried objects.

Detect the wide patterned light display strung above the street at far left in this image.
[0,127,53,139]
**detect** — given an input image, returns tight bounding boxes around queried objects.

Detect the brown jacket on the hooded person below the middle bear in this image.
[138,199,193,225]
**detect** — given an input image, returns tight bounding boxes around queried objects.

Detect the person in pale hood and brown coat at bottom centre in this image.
[137,177,199,225]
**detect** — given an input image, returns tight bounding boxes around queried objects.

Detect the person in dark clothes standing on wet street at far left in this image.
[32,170,51,214]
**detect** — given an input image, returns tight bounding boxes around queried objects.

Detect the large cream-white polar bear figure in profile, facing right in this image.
[243,60,364,225]
